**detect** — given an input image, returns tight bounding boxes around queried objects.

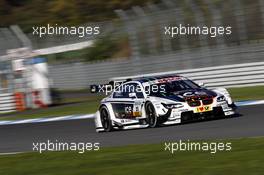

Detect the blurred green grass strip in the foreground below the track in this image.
[0,138,264,175]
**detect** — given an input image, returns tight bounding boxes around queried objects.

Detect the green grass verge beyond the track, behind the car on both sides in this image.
[0,86,264,120]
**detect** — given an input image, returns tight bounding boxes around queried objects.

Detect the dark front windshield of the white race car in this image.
[149,80,200,96]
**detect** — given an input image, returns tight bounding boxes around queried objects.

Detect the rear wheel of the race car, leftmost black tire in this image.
[99,106,113,132]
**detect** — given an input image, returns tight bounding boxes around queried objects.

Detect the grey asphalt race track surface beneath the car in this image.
[0,105,264,153]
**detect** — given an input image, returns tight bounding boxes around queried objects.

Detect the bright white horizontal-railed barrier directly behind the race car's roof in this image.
[113,62,264,87]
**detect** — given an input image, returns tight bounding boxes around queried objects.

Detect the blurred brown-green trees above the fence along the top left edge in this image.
[0,0,160,32]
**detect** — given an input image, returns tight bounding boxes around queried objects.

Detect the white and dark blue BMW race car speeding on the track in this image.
[92,75,236,132]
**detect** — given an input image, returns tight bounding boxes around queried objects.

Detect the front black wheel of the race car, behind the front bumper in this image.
[145,102,158,128]
